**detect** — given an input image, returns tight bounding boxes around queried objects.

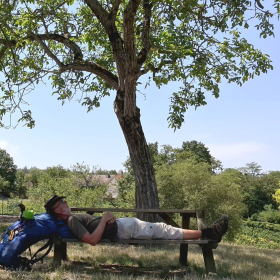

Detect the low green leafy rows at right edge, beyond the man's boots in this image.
[235,221,280,249]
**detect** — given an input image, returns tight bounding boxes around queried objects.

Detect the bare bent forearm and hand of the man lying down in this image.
[81,212,116,246]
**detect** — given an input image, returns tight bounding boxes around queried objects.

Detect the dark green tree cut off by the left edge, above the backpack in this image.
[0,149,17,196]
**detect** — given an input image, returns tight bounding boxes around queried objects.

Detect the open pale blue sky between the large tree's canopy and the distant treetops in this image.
[0,5,280,172]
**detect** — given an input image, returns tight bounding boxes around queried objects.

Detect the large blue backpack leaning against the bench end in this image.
[0,213,72,270]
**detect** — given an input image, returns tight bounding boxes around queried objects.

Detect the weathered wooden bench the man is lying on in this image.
[53,207,218,274]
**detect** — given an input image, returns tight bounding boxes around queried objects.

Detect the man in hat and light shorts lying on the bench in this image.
[45,195,228,246]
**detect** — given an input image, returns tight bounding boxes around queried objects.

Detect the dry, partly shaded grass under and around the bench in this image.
[0,225,280,280]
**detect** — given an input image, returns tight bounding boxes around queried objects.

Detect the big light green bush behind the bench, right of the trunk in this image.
[156,160,245,239]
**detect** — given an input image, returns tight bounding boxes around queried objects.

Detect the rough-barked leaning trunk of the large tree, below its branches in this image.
[115,95,159,222]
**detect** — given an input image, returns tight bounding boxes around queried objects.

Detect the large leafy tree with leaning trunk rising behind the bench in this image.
[0,0,278,218]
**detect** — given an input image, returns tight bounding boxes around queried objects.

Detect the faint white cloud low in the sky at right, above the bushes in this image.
[207,142,269,161]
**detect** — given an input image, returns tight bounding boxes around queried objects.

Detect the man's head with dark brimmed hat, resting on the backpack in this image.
[45,195,71,219]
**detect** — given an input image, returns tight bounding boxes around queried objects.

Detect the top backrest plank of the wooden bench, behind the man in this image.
[70,207,196,217]
